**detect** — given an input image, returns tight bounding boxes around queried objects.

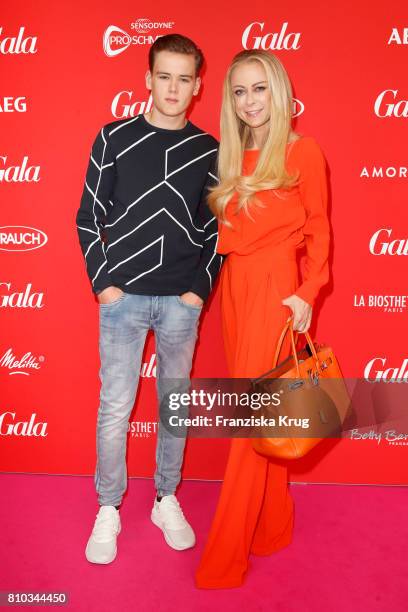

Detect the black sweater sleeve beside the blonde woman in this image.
[190,153,222,301]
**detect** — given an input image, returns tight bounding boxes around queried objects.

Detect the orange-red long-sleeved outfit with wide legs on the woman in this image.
[196,137,329,588]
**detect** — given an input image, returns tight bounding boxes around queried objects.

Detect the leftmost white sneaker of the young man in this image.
[85,506,121,563]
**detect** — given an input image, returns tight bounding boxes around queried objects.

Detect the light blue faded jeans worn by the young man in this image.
[95,293,202,506]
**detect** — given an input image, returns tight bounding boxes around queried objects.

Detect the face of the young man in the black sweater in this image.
[146,51,201,117]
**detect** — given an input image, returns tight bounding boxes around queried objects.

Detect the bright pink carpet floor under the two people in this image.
[0,474,408,612]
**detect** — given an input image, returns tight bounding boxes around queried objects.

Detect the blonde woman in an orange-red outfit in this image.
[196,50,329,588]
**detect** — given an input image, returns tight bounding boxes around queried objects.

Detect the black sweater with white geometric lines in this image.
[76,115,221,300]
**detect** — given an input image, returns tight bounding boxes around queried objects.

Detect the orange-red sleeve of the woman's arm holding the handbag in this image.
[295,139,330,306]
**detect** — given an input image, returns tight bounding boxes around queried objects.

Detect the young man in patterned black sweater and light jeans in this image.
[76,34,221,563]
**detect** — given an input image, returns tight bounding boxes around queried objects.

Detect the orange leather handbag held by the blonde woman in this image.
[252,317,351,459]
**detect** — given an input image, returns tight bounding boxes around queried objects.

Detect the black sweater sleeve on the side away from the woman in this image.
[76,128,115,293]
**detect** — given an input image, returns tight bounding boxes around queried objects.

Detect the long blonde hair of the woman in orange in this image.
[208,49,298,222]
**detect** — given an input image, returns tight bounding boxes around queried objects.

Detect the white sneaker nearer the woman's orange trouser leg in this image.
[151,495,195,550]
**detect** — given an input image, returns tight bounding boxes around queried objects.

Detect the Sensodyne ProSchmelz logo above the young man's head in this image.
[103,17,175,57]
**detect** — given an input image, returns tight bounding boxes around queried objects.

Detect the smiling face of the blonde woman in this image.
[231,61,271,128]
